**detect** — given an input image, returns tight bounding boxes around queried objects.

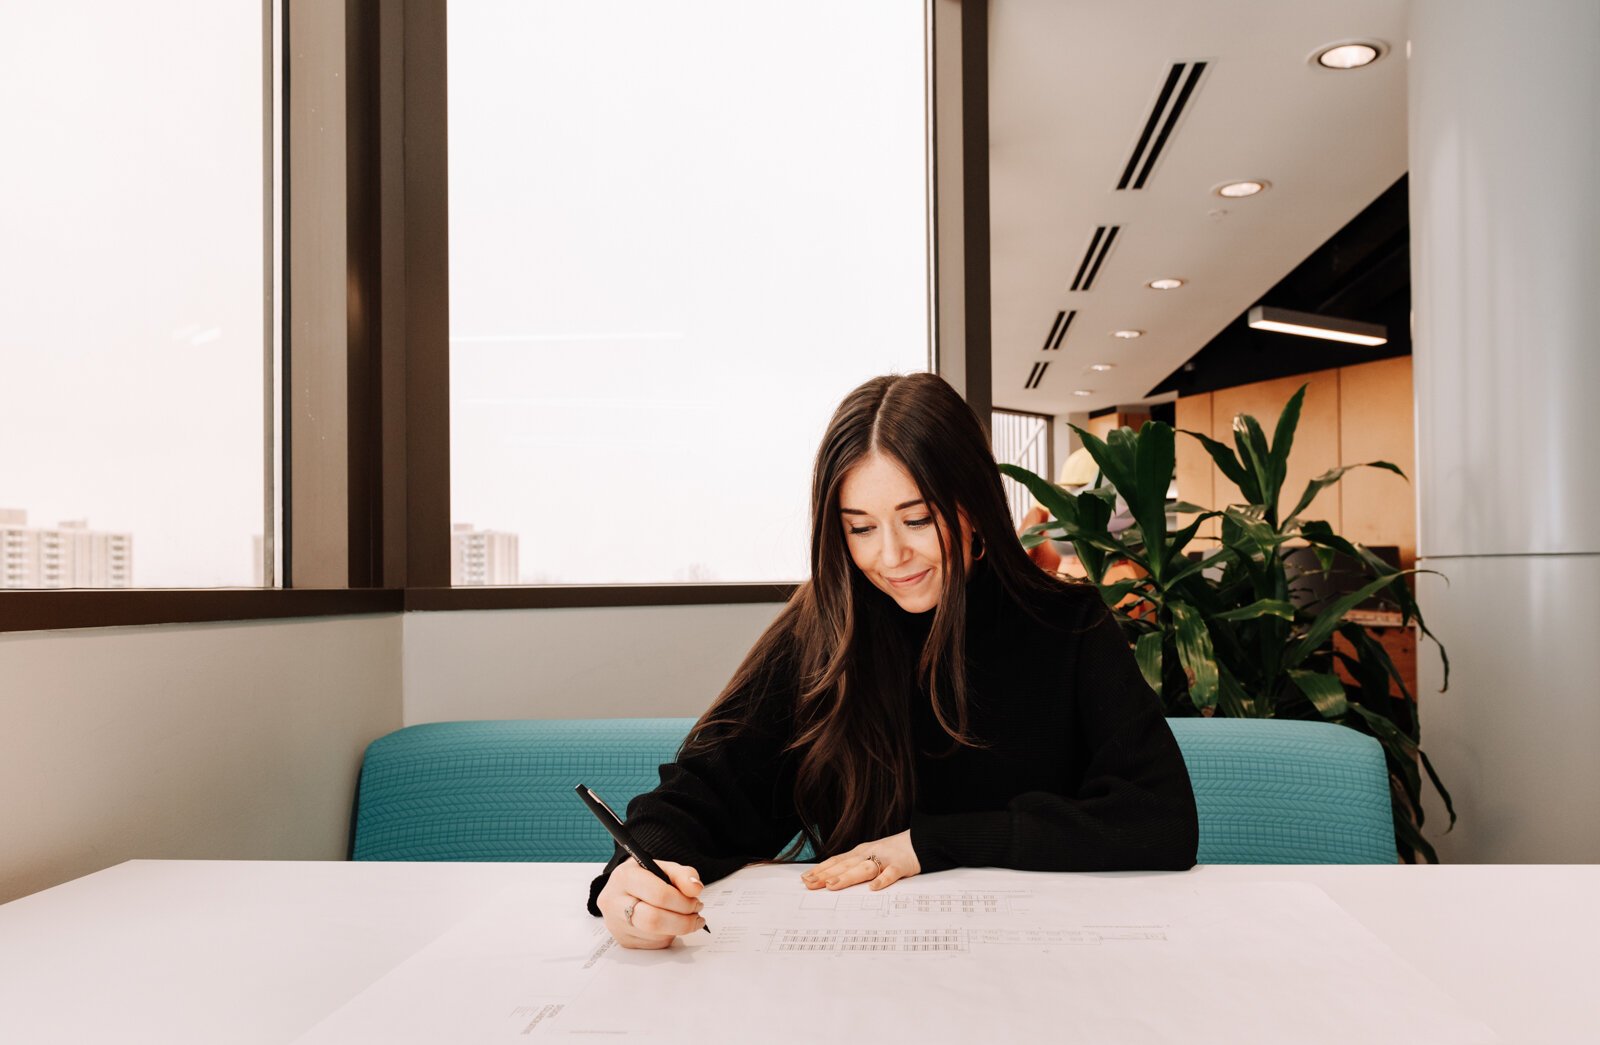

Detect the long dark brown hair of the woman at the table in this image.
[682,373,1061,859]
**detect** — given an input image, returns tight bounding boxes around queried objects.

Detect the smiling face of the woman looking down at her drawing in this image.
[838,451,966,613]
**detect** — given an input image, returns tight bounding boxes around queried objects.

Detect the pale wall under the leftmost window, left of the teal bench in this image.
[0,615,402,903]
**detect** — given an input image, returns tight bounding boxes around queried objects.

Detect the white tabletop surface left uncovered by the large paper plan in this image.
[0,861,1600,1043]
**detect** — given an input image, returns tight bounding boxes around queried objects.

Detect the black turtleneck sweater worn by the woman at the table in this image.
[589,567,1198,915]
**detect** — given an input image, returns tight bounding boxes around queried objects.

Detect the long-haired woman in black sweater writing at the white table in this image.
[589,374,1198,947]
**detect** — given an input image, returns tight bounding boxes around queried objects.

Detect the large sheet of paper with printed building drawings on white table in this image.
[304,867,1496,1045]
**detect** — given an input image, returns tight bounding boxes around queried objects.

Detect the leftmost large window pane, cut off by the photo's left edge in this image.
[0,0,272,587]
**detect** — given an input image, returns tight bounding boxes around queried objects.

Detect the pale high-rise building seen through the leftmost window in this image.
[0,507,133,587]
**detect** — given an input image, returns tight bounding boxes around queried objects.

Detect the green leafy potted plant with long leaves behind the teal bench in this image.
[1000,386,1456,861]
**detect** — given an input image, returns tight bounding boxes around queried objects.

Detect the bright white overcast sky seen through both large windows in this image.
[0,0,928,586]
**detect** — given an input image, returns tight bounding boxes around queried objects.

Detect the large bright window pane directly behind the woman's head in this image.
[448,0,930,584]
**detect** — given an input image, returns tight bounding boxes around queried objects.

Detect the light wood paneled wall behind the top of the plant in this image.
[1176,355,1416,567]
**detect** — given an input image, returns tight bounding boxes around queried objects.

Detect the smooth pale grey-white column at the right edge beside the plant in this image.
[1408,0,1600,863]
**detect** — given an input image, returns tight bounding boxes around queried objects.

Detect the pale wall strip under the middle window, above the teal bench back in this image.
[405,603,782,725]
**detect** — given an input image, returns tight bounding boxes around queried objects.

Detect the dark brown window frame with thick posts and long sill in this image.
[0,0,992,632]
